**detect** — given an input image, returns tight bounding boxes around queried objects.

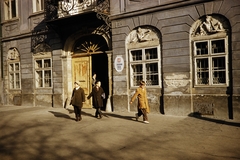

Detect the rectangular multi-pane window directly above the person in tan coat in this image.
[129,47,160,87]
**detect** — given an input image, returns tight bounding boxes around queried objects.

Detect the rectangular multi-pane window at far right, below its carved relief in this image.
[194,38,228,86]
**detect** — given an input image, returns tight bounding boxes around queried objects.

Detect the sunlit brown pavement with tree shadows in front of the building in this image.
[0,106,240,160]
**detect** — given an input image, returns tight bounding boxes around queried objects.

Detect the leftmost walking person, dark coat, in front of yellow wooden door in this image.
[70,81,85,122]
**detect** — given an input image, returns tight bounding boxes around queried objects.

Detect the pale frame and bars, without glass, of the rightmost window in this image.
[193,36,229,87]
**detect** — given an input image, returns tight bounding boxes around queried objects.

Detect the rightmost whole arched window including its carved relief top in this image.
[191,15,229,86]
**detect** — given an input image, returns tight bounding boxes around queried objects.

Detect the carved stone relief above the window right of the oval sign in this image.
[128,27,157,43]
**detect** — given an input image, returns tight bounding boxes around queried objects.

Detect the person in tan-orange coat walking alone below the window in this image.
[130,81,150,124]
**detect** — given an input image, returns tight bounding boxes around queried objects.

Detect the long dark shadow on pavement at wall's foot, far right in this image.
[188,113,240,127]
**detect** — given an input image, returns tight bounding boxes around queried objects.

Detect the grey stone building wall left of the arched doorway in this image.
[1,0,64,107]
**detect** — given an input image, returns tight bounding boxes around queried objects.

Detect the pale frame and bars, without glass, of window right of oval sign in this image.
[128,45,161,87]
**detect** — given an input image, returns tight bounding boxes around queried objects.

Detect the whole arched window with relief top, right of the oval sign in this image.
[126,26,161,87]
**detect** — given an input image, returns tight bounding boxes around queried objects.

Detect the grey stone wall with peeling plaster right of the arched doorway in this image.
[112,0,240,119]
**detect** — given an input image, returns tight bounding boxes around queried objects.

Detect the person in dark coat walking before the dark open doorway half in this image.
[87,81,105,118]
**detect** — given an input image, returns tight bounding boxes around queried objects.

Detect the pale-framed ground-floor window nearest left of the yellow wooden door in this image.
[35,59,52,88]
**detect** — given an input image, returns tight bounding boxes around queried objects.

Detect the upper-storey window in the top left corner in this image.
[3,0,17,20]
